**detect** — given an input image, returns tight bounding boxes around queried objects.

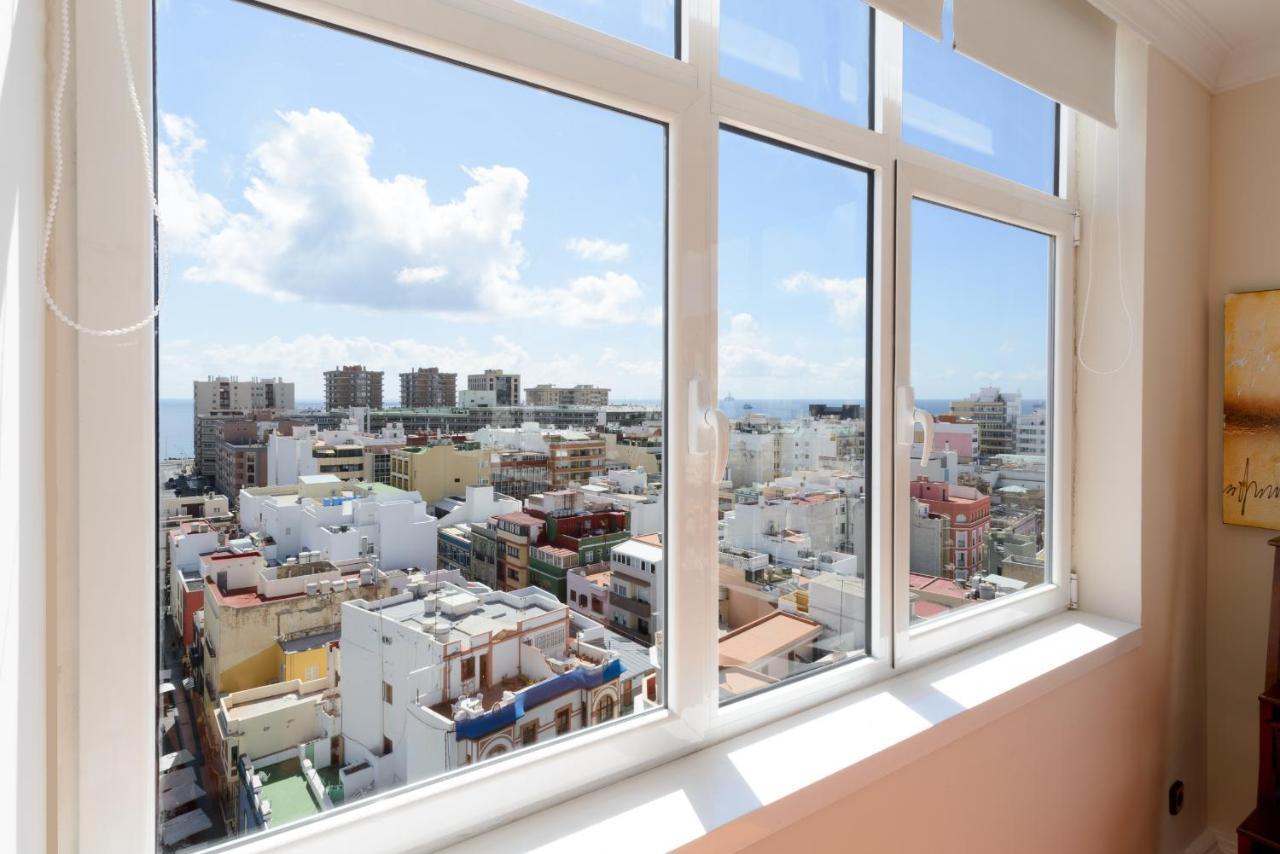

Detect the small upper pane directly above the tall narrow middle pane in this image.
[719,0,872,127]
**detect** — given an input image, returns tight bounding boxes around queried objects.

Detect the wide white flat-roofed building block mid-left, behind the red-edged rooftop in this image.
[239,475,436,571]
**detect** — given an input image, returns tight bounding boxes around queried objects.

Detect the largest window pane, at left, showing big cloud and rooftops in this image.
[156,0,666,844]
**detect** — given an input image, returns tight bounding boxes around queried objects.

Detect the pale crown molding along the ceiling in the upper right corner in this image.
[1089,0,1280,93]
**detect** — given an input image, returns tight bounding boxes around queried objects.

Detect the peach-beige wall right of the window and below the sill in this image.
[689,45,1213,854]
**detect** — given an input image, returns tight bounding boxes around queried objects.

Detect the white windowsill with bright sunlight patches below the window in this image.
[448,611,1142,854]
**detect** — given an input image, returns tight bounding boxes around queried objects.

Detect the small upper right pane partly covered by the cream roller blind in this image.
[902,0,1057,193]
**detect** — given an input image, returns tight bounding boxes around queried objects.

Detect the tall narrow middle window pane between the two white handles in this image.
[718,132,870,700]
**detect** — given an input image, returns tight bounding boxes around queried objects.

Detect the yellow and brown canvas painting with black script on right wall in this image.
[1222,291,1280,530]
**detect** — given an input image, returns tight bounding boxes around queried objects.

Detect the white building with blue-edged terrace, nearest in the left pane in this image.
[342,580,624,796]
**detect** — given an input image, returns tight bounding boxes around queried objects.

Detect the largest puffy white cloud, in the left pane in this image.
[160,109,652,325]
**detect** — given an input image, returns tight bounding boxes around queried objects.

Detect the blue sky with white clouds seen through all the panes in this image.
[156,0,1053,401]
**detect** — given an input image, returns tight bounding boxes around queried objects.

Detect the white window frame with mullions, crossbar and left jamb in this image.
[60,0,1073,851]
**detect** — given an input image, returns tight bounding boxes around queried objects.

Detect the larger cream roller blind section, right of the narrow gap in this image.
[952,0,1116,127]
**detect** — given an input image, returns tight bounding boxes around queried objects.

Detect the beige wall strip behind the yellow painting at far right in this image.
[1206,73,1280,831]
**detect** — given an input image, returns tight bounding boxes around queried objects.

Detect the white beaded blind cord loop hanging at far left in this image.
[40,0,169,337]
